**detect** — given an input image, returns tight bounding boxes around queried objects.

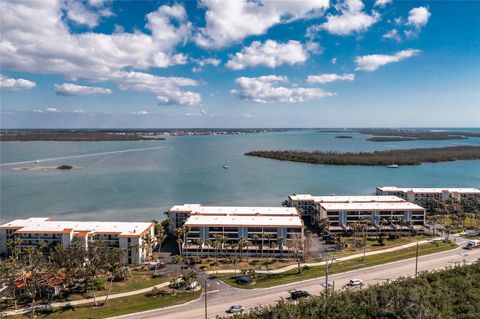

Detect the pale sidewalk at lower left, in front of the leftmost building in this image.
[0,281,170,317]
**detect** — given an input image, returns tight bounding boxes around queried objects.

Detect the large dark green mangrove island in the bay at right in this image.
[245,146,480,166]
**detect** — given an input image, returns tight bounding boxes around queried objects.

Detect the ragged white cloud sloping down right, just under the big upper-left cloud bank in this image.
[113,71,202,106]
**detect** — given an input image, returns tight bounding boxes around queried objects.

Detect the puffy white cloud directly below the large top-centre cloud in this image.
[225,40,307,70]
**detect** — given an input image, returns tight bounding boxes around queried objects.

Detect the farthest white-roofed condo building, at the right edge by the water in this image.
[376,186,480,209]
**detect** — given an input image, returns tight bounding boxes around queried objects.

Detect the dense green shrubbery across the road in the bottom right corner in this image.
[226,262,480,319]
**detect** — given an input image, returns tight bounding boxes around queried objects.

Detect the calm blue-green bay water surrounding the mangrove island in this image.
[0,131,480,222]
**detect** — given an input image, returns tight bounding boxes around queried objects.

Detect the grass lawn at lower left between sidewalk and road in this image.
[11,290,201,319]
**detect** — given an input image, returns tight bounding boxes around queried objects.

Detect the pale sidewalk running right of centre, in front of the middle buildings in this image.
[206,237,442,275]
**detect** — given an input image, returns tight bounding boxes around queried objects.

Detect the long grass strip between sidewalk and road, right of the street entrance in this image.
[219,242,456,289]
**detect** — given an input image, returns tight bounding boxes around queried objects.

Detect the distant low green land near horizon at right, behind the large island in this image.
[358,129,480,142]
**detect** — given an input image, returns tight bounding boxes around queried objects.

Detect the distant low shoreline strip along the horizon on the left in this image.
[0,128,287,142]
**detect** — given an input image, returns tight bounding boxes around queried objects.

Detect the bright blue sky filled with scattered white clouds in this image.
[0,0,480,128]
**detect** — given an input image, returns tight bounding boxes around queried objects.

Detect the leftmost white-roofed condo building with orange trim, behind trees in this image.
[0,217,154,265]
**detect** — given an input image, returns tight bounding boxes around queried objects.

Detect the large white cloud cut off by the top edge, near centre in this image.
[195,0,329,49]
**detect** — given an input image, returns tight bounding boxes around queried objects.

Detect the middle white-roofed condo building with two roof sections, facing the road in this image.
[168,204,303,256]
